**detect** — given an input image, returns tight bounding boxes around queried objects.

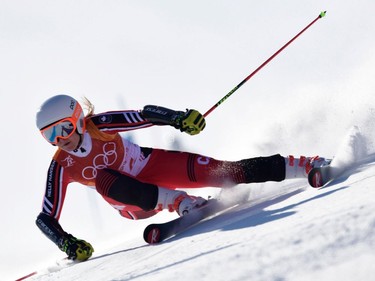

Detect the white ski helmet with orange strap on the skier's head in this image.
[36,95,85,134]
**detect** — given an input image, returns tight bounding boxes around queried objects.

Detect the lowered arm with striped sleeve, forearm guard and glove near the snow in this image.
[36,160,94,261]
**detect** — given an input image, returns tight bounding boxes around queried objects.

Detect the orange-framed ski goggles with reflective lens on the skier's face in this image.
[40,117,77,145]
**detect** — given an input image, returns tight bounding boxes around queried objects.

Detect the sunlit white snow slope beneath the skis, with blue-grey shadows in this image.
[22,128,375,281]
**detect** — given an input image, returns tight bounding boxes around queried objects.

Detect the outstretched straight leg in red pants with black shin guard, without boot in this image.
[137,149,285,188]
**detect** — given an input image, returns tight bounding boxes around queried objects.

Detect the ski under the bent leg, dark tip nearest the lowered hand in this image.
[143,199,233,244]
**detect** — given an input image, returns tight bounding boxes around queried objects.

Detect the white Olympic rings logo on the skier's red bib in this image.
[82,142,117,180]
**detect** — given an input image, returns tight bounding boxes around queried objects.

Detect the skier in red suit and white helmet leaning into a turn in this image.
[36,95,326,261]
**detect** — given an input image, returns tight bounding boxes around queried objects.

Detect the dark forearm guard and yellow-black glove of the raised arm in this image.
[141,105,206,135]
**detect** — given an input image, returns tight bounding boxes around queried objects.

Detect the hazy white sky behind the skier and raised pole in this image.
[0,0,375,274]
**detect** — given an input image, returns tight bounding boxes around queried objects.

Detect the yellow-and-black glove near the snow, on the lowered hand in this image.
[59,234,94,261]
